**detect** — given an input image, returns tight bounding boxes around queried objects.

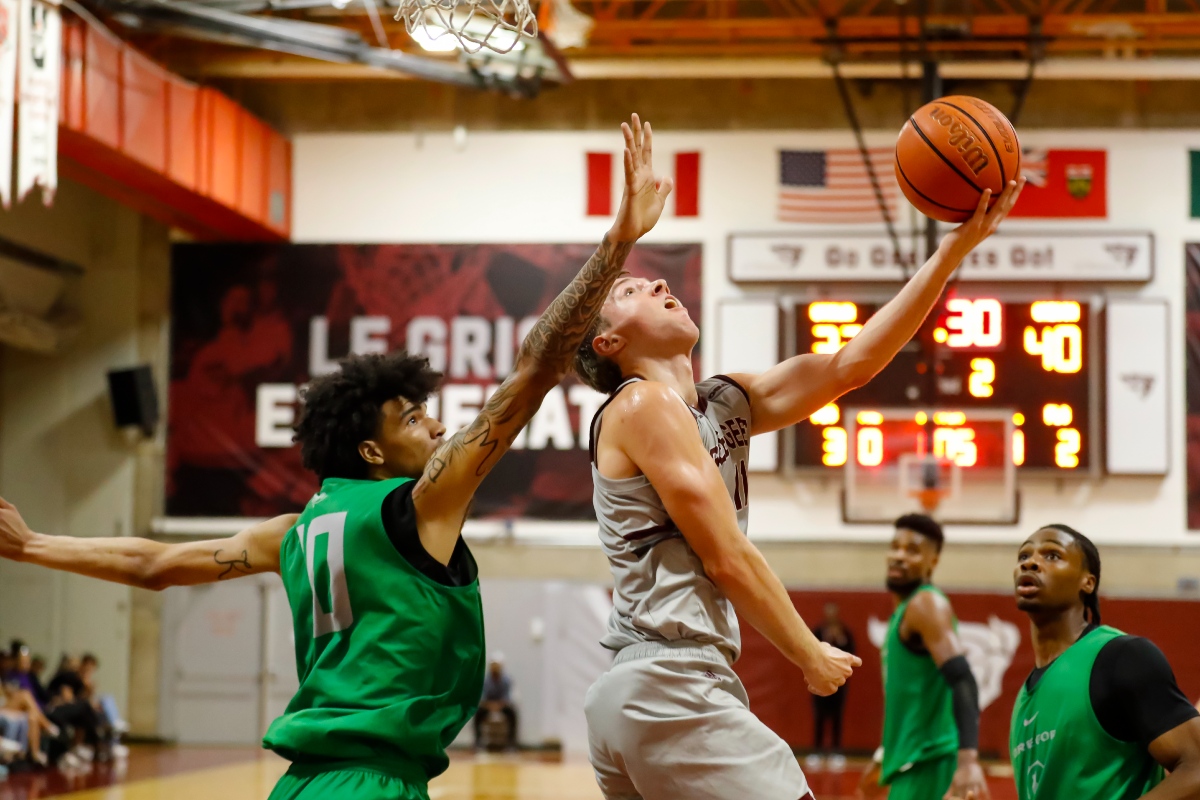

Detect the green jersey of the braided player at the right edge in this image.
[1009,625,1163,800]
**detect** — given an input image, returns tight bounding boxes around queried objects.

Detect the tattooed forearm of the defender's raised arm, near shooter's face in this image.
[517,234,634,371]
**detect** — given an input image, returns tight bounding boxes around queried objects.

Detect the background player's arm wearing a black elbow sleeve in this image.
[901,591,991,800]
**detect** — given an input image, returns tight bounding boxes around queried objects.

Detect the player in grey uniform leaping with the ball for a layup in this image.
[575,182,1020,800]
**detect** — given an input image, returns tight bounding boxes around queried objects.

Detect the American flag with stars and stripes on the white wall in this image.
[779,148,900,222]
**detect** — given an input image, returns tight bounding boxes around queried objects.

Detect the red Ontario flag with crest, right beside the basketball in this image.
[1009,149,1109,219]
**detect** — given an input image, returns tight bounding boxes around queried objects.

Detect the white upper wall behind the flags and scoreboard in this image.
[294,128,1200,546]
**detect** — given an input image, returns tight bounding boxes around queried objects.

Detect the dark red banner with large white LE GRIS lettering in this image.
[167,245,701,519]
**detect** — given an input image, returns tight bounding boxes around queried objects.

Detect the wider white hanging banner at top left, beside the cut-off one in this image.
[17,0,62,205]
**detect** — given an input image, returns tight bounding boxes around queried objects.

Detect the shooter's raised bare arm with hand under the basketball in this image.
[731,178,1025,434]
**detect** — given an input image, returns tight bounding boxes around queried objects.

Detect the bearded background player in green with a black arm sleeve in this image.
[859,513,989,800]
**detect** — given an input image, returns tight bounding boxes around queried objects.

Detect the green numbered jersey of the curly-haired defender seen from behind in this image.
[263,479,485,777]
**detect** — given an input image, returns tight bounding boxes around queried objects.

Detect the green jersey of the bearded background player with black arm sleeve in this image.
[880,585,959,800]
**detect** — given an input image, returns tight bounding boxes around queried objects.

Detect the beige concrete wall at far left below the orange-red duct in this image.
[0,182,166,711]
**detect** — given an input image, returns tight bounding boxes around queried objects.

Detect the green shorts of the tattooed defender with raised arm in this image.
[270,763,430,800]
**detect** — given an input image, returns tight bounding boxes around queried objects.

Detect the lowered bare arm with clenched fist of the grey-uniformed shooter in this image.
[605,381,863,694]
